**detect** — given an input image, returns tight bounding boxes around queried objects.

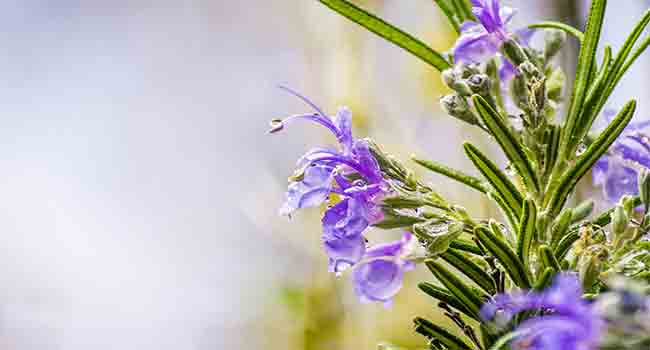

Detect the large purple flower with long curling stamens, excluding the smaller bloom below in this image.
[271,87,388,274]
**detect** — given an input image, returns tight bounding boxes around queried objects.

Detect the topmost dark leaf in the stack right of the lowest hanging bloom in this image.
[474,226,530,289]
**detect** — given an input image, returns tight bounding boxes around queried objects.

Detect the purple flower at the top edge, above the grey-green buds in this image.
[452,0,534,82]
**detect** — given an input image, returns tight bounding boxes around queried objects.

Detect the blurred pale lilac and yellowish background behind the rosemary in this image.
[0,0,650,350]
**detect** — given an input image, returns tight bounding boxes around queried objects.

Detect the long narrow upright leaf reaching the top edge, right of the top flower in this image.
[560,0,607,159]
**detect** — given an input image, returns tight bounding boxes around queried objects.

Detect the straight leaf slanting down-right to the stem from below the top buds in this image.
[472,95,539,192]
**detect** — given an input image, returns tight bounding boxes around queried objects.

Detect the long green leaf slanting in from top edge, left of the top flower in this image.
[319,0,451,71]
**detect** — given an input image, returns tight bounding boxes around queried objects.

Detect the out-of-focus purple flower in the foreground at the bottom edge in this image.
[481,274,605,350]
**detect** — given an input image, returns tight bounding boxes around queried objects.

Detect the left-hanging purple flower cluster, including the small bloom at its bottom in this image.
[270,87,416,303]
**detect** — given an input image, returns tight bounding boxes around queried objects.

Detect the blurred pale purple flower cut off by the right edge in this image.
[592,110,650,202]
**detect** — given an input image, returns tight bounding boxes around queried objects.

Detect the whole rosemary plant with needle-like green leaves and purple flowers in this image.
[271,0,650,350]
